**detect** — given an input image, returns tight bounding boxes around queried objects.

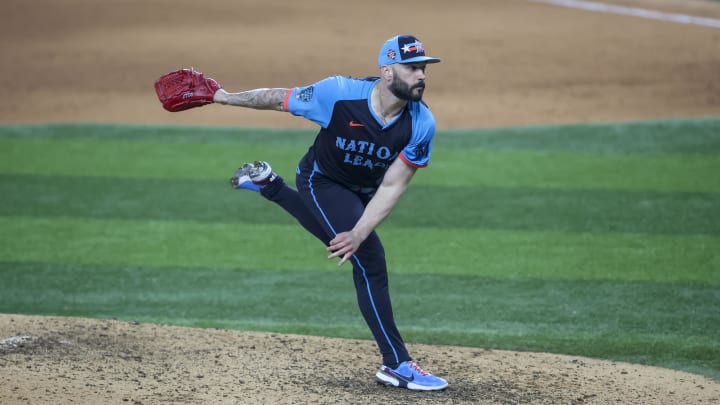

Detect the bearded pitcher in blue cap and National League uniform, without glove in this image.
[213,35,448,390]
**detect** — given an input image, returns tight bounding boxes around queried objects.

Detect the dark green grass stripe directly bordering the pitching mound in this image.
[0,262,720,378]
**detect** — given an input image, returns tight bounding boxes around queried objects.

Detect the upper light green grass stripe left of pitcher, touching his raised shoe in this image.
[0,138,303,180]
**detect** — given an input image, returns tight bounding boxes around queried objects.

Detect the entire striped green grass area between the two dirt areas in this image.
[0,119,720,379]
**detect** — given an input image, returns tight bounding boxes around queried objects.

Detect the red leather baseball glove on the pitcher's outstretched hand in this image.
[155,69,222,112]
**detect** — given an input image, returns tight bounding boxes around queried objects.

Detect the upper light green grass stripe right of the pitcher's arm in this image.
[422,149,720,192]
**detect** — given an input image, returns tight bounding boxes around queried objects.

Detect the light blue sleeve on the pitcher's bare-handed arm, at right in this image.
[400,103,435,167]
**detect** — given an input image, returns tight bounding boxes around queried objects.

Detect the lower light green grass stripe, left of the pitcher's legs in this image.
[0,217,333,270]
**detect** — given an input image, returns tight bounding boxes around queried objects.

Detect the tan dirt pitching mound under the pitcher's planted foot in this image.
[0,315,720,404]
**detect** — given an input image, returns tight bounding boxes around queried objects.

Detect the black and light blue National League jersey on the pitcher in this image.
[284,76,435,188]
